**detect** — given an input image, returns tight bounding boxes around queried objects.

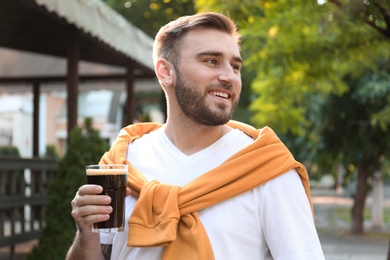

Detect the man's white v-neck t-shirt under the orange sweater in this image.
[100,128,324,260]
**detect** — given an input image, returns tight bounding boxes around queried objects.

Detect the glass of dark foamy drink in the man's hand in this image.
[86,164,127,233]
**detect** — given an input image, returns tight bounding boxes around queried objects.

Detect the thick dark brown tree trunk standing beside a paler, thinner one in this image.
[351,161,370,235]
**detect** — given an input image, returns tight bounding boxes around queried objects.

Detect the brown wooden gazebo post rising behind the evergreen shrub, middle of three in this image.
[66,30,80,142]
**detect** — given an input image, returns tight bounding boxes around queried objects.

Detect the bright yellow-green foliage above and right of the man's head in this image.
[197,0,390,135]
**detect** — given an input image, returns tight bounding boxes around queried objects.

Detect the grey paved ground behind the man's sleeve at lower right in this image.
[312,189,390,260]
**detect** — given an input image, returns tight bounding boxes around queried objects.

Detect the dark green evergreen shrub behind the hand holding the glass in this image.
[28,119,109,260]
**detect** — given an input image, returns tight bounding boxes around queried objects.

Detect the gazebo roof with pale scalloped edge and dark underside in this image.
[0,0,153,77]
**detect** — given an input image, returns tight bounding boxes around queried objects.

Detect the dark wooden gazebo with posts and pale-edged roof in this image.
[0,0,154,156]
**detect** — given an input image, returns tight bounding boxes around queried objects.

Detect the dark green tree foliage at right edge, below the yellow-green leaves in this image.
[319,66,390,170]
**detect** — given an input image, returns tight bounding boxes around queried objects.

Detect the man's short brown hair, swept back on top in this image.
[153,12,240,65]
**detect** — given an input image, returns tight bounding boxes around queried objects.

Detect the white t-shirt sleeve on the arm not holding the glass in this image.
[259,170,324,260]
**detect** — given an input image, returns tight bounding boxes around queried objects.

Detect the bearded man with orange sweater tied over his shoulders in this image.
[67,13,324,260]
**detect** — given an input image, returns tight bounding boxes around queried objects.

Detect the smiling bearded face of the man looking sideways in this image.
[175,29,242,126]
